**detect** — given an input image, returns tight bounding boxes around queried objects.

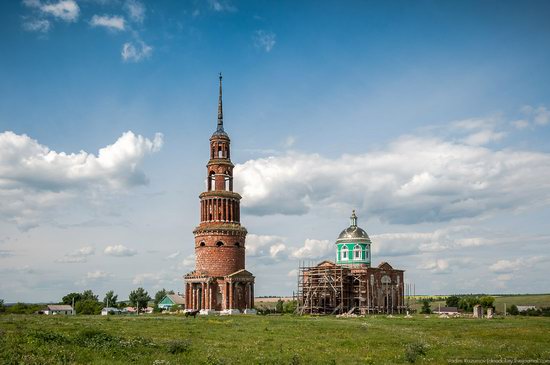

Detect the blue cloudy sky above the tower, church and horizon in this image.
[0,0,550,301]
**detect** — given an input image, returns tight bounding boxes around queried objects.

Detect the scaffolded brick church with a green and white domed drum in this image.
[298,211,406,314]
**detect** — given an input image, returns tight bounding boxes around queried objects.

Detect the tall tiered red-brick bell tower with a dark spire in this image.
[185,73,254,314]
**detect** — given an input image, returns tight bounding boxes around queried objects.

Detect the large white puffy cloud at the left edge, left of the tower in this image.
[0,131,163,230]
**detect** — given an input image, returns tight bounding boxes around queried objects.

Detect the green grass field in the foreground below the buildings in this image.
[0,315,550,365]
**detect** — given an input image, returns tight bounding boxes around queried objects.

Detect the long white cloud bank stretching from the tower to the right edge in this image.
[235,136,550,224]
